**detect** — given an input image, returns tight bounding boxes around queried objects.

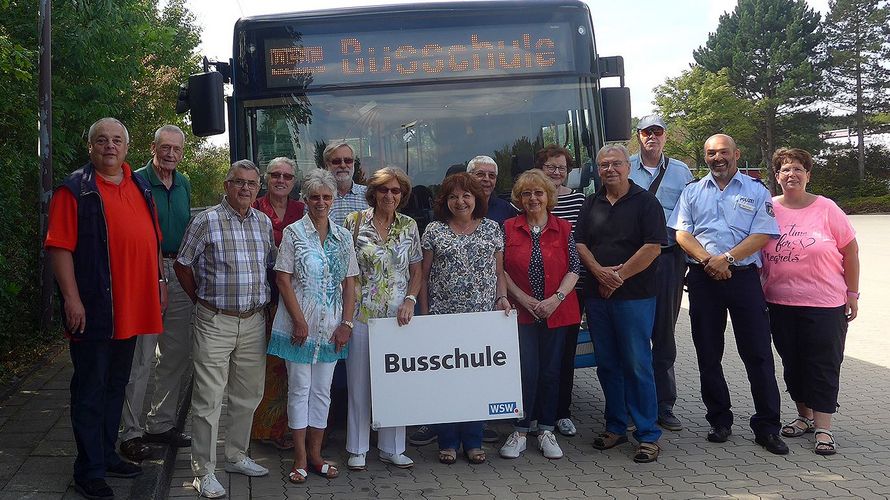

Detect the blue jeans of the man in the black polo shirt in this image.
[587,297,661,443]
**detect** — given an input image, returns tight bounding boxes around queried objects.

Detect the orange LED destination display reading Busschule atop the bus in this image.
[265,23,575,87]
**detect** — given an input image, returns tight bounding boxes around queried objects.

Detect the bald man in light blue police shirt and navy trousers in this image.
[668,134,788,455]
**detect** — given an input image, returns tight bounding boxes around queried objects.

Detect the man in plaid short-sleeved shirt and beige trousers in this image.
[174,160,276,498]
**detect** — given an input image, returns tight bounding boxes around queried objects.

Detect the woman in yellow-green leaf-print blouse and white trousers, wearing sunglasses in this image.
[345,167,423,470]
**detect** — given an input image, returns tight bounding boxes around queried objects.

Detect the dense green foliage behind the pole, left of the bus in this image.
[0,0,200,361]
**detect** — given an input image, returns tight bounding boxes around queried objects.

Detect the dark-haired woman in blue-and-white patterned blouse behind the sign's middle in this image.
[420,172,510,464]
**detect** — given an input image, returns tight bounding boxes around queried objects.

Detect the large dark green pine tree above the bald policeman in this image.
[693,0,824,190]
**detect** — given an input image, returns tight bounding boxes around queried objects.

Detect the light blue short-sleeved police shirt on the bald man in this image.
[668,172,779,267]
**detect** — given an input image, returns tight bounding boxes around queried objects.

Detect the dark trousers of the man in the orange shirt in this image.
[69,337,136,482]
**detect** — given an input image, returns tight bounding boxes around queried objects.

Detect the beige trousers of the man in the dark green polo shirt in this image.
[121,258,194,441]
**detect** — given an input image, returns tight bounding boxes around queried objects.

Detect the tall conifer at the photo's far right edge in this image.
[825,0,890,179]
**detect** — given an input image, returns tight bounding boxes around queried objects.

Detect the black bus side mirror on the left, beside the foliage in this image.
[176,71,226,137]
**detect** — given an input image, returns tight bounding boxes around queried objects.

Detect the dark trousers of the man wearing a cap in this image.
[652,245,686,414]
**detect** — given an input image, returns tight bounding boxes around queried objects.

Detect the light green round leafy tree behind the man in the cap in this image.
[653,66,756,166]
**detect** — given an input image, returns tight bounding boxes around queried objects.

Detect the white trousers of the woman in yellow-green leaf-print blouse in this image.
[346,321,405,455]
